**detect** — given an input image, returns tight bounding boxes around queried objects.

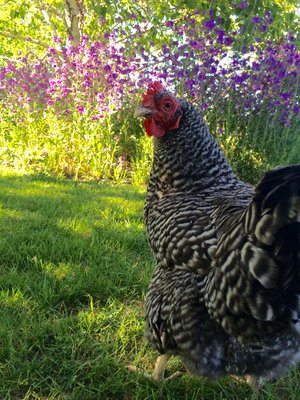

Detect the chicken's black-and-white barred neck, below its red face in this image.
[148,103,246,197]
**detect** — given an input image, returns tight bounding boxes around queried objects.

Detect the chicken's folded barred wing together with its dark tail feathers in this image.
[205,165,300,343]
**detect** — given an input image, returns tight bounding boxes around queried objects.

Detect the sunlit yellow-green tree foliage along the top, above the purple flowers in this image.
[0,0,299,61]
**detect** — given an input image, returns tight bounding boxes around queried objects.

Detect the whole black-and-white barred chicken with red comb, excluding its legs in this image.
[139,84,300,378]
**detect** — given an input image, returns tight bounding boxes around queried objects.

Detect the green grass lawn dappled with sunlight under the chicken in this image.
[0,173,300,400]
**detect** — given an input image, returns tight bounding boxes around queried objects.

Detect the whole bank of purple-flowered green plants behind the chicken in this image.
[0,9,300,180]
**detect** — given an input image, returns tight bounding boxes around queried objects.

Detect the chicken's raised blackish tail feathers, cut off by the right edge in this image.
[242,165,300,322]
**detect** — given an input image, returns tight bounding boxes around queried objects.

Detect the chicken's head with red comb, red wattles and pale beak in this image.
[135,82,182,138]
